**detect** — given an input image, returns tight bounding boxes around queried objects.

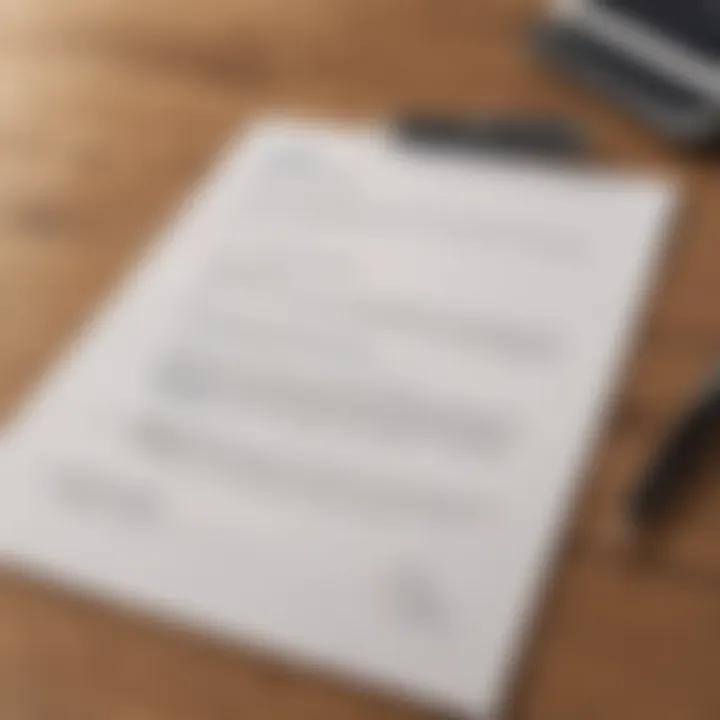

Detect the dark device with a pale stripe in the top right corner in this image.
[532,0,720,146]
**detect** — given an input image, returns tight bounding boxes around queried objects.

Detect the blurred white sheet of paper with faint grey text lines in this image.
[0,123,674,717]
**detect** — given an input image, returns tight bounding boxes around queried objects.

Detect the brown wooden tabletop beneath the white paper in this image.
[0,0,720,720]
